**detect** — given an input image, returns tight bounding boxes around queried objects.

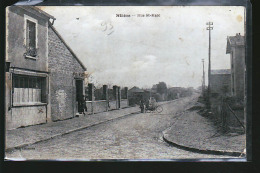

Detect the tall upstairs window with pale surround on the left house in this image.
[24,15,38,57]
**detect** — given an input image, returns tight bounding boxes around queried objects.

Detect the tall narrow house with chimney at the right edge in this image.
[226,33,245,99]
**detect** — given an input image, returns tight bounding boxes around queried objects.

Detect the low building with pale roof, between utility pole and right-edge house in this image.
[210,69,231,95]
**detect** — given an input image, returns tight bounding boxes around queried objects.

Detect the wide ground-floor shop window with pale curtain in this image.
[13,75,46,105]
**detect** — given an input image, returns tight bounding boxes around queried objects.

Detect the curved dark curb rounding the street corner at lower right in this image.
[163,133,245,157]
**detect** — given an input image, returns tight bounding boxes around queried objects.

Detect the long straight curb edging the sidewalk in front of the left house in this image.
[5,111,141,152]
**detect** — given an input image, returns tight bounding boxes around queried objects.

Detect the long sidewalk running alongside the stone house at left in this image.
[5,107,140,151]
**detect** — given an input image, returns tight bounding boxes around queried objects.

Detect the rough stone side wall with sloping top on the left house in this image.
[48,27,84,121]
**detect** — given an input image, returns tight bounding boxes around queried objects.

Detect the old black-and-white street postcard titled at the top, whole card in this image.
[5,3,247,161]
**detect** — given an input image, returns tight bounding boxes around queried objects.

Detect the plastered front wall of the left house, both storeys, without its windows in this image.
[5,6,48,130]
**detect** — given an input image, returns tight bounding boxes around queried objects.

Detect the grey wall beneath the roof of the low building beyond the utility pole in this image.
[211,74,231,94]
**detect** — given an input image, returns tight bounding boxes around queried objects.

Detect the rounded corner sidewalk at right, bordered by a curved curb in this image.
[163,111,246,156]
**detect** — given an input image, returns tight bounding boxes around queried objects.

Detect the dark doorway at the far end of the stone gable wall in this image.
[76,79,84,113]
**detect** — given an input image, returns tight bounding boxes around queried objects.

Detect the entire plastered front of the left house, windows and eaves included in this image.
[5,6,55,129]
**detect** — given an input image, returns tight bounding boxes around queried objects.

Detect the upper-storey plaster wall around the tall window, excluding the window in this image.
[7,6,48,71]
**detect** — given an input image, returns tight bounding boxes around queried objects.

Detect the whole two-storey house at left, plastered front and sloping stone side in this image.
[5,6,86,130]
